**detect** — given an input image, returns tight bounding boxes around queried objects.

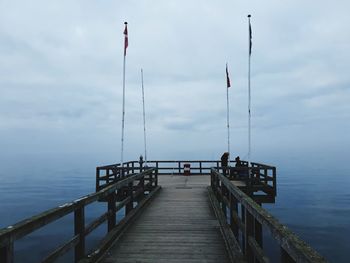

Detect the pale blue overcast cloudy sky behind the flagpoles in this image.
[0,0,350,168]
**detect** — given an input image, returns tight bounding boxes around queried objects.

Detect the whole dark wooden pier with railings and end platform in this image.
[0,160,326,263]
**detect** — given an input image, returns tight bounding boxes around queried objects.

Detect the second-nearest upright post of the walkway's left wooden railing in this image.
[74,206,85,262]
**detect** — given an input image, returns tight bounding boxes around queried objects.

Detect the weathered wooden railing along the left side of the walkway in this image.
[0,168,159,263]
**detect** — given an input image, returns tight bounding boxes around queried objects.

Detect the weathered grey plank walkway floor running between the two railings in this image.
[103,176,230,263]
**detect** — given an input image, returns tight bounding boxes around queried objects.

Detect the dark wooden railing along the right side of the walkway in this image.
[210,168,326,262]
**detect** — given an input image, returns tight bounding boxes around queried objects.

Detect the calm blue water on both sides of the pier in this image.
[0,158,350,262]
